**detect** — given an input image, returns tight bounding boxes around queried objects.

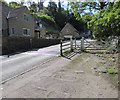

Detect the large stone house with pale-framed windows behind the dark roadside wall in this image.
[0,2,45,38]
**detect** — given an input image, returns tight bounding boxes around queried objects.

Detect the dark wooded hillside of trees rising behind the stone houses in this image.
[6,0,86,33]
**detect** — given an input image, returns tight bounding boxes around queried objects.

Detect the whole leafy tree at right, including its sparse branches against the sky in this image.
[70,1,120,37]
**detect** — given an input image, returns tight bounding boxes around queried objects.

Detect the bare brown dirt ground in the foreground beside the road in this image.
[2,53,118,98]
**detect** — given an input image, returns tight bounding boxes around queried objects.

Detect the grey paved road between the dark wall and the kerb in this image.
[0,45,60,81]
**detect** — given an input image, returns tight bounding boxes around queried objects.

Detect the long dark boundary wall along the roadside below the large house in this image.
[2,37,60,54]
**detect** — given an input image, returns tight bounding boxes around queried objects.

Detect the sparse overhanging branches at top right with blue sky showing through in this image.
[70,0,112,20]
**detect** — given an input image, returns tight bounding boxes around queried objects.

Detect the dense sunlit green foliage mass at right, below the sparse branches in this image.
[88,2,120,37]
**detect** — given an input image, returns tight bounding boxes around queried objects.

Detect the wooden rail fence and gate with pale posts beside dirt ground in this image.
[60,37,106,56]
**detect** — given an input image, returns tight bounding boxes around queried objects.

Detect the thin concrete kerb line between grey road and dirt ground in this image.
[0,56,57,85]
